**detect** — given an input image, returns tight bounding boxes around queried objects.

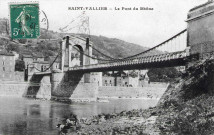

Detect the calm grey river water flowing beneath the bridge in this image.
[0,97,158,135]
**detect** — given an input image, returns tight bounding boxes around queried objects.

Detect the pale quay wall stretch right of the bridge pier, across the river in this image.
[98,83,168,98]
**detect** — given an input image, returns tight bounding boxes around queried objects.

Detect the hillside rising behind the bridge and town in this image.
[0,19,159,58]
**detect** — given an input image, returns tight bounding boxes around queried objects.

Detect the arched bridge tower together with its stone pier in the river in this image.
[51,36,98,100]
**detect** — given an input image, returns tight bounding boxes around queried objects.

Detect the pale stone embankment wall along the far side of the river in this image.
[0,81,168,103]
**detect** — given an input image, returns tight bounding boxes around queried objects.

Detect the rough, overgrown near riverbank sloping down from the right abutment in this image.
[69,58,214,135]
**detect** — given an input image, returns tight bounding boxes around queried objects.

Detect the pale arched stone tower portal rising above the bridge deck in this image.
[60,36,93,83]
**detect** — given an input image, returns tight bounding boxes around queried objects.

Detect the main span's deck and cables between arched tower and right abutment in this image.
[67,29,189,72]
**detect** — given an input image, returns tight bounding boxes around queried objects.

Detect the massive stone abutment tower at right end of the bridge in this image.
[186,1,214,59]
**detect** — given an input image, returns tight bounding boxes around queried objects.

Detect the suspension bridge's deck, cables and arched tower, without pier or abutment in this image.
[15,26,190,76]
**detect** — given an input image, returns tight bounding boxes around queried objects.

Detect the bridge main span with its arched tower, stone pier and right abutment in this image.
[27,2,214,100]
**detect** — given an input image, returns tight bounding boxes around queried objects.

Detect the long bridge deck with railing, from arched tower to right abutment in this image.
[68,51,188,72]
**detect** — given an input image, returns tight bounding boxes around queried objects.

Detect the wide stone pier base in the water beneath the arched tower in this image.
[51,72,98,100]
